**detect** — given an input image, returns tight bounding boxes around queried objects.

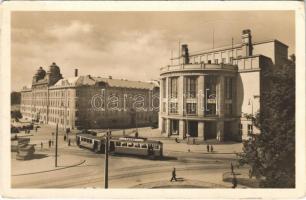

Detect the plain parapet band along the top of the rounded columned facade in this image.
[160,63,238,75]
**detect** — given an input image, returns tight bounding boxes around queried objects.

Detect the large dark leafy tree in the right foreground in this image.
[239,55,295,188]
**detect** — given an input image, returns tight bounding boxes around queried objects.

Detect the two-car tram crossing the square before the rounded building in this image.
[76,133,163,159]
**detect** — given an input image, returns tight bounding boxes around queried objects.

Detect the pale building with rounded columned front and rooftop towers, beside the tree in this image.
[159,30,288,141]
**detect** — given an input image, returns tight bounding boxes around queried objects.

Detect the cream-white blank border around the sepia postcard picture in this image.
[0,1,306,199]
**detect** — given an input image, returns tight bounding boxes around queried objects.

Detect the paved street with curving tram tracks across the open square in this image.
[12,127,246,188]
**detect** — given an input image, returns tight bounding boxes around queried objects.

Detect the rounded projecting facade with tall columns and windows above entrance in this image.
[160,63,239,141]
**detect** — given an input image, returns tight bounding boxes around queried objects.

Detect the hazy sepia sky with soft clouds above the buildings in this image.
[11,11,295,91]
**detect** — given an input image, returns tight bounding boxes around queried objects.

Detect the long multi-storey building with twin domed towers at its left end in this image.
[21,63,159,129]
